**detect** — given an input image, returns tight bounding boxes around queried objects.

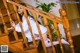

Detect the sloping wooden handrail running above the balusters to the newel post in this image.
[7,0,63,24]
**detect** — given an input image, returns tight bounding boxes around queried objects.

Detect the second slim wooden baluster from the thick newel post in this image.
[43,17,56,53]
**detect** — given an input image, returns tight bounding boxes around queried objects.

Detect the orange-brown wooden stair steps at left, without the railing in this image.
[0,0,39,53]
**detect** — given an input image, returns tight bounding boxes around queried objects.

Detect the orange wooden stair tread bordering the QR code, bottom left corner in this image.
[0,40,23,53]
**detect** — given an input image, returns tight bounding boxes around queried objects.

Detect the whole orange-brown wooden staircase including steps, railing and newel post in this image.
[0,0,74,53]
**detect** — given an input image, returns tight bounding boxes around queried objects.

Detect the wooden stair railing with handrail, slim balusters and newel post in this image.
[0,0,74,53]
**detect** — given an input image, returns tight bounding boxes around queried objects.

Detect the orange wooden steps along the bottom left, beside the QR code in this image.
[0,35,38,53]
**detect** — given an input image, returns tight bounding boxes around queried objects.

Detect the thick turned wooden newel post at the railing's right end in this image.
[60,10,74,53]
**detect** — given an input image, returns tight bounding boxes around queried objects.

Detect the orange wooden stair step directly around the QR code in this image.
[0,40,24,53]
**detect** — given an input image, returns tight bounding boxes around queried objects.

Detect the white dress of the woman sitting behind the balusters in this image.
[15,16,47,42]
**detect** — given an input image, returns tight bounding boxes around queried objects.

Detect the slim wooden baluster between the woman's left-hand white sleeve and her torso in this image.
[13,5,28,48]
